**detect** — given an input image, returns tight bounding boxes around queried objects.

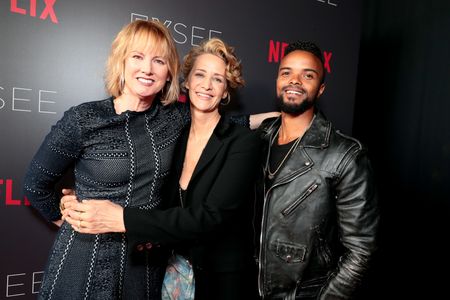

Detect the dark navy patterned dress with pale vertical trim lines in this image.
[24,98,190,300]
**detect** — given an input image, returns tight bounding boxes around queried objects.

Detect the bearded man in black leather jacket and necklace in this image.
[255,42,379,299]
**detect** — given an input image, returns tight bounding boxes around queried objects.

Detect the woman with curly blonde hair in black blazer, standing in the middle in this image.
[64,39,260,300]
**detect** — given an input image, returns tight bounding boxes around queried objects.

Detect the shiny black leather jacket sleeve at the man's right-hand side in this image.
[319,144,379,300]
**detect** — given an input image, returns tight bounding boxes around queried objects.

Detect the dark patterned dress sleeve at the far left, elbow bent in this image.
[23,108,81,221]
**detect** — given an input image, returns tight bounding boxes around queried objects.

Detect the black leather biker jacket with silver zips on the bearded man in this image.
[255,113,379,299]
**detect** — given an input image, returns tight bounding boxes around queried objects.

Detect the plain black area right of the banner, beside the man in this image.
[353,0,450,299]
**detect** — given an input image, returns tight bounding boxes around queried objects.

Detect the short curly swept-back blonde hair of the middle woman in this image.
[182,38,245,104]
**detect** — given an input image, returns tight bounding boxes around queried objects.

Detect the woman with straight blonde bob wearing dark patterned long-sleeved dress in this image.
[24,21,190,299]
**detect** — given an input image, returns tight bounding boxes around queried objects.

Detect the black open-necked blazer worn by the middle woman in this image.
[124,118,261,272]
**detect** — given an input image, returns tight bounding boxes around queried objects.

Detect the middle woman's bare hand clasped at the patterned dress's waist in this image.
[63,196,125,234]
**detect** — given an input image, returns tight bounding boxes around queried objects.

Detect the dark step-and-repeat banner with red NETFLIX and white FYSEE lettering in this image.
[0,0,362,299]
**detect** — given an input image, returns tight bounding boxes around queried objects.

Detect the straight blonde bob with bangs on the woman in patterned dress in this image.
[105,20,180,105]
